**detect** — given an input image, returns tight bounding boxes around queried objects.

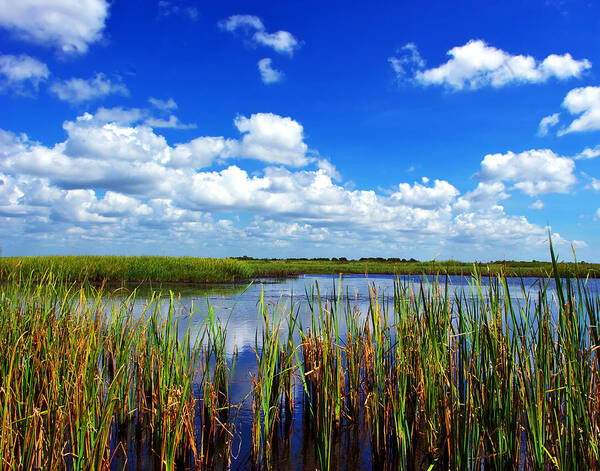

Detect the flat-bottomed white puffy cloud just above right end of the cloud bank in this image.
[477,149,576,196]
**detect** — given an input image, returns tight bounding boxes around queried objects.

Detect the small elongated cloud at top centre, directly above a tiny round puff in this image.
[219,15,300,56]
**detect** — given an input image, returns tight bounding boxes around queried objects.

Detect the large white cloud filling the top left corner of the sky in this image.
[0,0,109,53]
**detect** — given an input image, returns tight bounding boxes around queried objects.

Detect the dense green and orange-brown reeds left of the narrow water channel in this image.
[0,273,238,470]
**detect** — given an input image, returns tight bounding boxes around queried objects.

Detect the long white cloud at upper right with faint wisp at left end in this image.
[388,40,592,90]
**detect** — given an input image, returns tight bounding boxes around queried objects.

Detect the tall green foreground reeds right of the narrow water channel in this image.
[264,245,600,470]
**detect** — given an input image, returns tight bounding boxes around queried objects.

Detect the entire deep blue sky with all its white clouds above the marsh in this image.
[0,0,600,262]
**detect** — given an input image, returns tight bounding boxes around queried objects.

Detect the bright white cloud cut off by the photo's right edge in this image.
[558,87,600,136]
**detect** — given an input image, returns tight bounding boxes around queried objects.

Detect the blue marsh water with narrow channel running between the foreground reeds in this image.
[106,275,600,470]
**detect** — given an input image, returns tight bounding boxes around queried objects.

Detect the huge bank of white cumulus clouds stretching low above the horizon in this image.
[0,109,580,253]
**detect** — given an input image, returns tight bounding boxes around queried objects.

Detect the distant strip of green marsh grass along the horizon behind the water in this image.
[0,256,600,283]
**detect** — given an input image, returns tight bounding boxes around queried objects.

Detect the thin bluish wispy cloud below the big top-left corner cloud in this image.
[50,73,129,103]
